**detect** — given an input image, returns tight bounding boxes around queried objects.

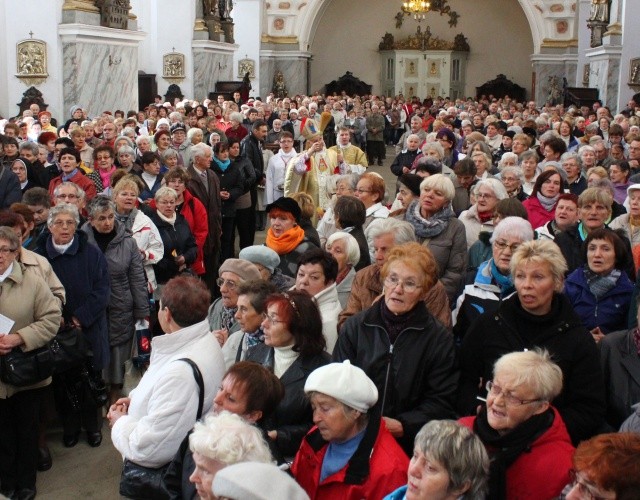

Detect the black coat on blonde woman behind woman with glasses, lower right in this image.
[458,293,606,444]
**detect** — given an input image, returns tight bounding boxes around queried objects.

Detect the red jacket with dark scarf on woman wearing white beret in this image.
[291,417,409,500]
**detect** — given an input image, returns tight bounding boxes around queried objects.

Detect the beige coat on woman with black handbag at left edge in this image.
[0,262,62,399]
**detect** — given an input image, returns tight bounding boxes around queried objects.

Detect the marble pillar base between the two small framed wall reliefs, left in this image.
[192,40,238,101]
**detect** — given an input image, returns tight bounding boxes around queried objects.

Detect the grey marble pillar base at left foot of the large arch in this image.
[259,50,311,98]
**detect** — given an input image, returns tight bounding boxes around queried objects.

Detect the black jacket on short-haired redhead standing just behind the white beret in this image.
[333,299,458,455]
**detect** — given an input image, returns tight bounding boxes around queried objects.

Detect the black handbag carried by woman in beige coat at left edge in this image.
[0,325,87,387]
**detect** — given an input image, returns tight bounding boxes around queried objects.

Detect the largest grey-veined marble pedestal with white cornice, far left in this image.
[58,24,146,116]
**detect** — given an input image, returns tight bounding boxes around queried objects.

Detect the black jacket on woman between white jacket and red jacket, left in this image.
[151,212,198,285]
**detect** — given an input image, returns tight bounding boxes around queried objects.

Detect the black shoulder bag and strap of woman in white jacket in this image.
[120,358,204,500]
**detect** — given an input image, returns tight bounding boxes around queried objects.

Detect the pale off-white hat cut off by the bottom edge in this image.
[211,462,309,500]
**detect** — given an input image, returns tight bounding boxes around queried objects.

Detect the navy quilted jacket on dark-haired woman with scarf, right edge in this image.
[564,266,633,333]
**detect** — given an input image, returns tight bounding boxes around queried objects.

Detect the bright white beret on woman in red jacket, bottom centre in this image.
[304,360,378,413]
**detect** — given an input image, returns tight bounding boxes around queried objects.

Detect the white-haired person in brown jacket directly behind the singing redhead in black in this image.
[338,218,451,330]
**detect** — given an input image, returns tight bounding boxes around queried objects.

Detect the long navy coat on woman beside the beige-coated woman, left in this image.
[36,231,111,370]
